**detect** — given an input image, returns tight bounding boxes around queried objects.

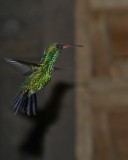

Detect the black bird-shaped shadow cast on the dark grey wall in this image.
[19,82,73,157]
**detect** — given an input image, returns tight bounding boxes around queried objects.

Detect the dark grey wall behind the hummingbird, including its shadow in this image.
[0,0,74,160]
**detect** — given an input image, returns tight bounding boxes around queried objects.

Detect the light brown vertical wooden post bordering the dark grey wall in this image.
[75,0,93,160]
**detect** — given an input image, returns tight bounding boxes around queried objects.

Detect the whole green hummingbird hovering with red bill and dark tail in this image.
[5,43,82,115]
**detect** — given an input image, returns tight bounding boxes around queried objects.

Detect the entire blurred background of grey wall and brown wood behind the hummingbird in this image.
[0,0,128,160]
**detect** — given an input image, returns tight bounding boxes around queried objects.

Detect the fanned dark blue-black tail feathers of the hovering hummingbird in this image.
[13,93,37,115]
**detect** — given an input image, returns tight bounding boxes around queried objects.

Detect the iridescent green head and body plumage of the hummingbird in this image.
[20,43,61,95]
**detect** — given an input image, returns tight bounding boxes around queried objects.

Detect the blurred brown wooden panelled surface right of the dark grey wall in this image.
[75,0,128,160]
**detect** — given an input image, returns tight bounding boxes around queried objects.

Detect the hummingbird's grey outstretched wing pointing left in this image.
[4,58,38,76]
